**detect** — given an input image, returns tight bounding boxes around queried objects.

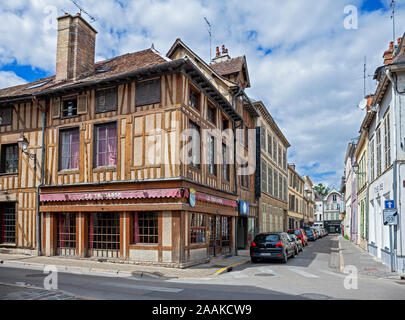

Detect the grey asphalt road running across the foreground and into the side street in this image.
[0,236,405,300]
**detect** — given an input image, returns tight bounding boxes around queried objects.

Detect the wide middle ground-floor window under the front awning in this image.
[89,212,120,252]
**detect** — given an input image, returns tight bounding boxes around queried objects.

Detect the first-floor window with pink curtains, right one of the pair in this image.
[96,123,118,167]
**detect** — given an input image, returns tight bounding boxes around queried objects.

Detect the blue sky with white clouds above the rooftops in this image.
[0,0,405,188]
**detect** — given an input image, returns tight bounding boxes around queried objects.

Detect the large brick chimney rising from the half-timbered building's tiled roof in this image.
[56,13,97,82]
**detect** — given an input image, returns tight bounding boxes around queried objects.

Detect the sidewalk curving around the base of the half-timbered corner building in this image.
[0,250,250,279]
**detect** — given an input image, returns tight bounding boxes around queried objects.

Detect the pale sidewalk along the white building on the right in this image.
[339,236,401,279]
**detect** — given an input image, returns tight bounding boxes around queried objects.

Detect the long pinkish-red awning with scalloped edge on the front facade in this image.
[40,189,183,202]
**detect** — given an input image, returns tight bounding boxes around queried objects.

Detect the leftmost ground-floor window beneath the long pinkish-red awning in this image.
[57,213,76,255]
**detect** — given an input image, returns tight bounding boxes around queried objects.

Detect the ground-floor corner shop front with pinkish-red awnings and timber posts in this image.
[40,182,237,267]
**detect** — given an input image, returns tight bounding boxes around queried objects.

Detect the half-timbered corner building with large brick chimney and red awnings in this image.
[0,14,257,267]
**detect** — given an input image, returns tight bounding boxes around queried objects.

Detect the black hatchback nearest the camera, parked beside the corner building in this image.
[250,232,295,263]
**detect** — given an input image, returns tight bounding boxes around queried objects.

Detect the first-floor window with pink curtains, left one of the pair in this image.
[59,128,80,170]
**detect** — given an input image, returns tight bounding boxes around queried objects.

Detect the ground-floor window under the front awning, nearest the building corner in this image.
[132,212,159,244]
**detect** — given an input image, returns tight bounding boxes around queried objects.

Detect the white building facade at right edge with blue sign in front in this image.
[367,41,405,272]
